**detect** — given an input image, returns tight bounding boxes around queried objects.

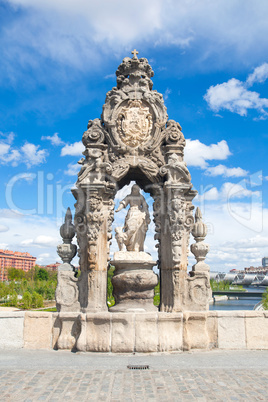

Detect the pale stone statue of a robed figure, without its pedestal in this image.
[115,184,150,252]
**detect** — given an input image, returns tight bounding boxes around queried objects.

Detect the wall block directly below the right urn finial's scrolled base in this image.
[183,312,210,350]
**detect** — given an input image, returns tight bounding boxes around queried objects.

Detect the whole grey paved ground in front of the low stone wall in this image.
[0,350,268,402]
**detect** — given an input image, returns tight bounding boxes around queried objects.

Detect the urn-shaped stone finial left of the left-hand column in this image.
[57,208,77,264]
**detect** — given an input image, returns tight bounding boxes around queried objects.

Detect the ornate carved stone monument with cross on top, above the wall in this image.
[57,50,210,318]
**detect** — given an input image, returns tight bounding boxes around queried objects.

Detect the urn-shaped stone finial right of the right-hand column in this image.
[191,207,209,272]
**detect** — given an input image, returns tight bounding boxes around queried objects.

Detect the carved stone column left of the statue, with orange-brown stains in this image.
[73,182,114,312]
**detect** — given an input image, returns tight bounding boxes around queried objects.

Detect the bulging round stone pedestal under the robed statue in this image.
[110,251,158,312]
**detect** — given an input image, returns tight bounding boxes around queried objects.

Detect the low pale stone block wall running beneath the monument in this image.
[0,311,268,353]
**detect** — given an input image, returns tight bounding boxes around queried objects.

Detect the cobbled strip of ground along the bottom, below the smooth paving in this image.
[0,367,268,402]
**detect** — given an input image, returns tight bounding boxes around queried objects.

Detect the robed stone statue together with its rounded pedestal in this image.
[110,184,158,312]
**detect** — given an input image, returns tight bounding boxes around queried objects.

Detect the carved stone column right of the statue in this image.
[160,182,196,312]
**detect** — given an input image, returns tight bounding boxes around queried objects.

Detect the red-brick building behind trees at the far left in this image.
[0,250,36,282]
